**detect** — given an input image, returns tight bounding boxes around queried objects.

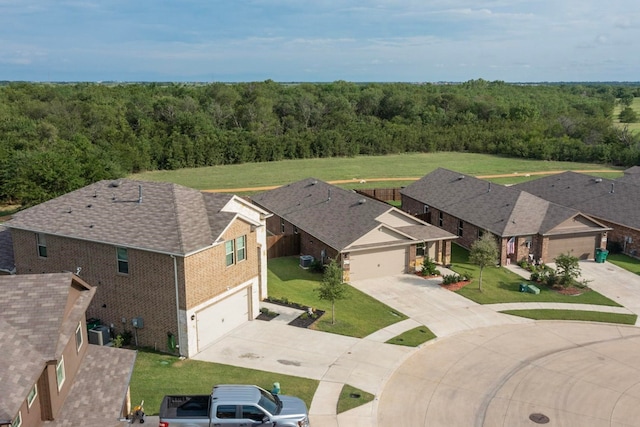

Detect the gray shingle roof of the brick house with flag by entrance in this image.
[401,168,592,237]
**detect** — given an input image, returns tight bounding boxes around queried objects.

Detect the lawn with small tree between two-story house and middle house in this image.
[268,257,407,338]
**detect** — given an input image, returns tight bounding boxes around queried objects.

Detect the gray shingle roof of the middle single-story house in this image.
[252,178,455,251]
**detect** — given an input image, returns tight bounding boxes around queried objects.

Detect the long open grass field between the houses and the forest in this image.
[130,152,622,190]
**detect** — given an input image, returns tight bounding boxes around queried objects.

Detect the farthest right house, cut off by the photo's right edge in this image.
[515,170,640,256]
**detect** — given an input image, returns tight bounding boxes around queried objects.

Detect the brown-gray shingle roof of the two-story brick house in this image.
[6,179,238,255]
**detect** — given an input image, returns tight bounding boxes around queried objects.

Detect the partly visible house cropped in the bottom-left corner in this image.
[0,273,136,427]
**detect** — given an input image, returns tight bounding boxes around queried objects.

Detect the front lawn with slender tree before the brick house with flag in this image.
[451,244,621,307]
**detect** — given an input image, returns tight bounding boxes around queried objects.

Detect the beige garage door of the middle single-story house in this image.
[349,247,407,281]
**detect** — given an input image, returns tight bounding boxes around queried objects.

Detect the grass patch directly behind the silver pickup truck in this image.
[130,351,318,415]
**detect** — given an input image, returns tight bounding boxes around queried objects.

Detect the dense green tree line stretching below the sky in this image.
[0,80,640,205]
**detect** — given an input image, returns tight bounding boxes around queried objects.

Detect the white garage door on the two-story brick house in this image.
[196,288,251,351]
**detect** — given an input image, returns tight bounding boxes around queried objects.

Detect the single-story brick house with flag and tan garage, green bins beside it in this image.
[401,168,610,265]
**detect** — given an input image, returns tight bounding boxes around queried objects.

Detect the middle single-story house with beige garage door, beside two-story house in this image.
[252,178,456,281]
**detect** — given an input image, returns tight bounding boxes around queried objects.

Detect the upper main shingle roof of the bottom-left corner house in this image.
[0,273,96,419]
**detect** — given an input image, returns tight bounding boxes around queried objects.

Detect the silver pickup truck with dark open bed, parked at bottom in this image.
[159,384,309,427]
